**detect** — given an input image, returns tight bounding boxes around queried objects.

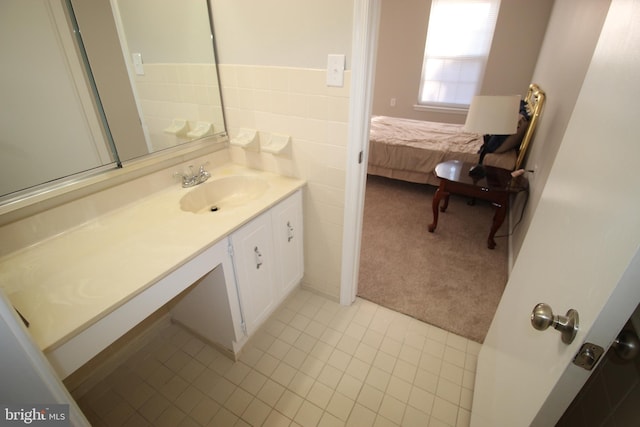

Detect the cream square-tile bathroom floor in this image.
[77,290,480,427]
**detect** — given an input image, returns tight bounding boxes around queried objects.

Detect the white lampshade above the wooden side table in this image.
[464,95,520,135]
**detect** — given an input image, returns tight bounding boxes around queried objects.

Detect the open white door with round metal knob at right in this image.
[471,0,640,427]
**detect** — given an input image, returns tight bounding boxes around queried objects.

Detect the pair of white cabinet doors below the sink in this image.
[231,190,304,335]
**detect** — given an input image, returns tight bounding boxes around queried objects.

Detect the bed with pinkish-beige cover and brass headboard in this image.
[367,84,545,185]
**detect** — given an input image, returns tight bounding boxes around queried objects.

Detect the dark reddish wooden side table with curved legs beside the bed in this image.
[429,160,528,249]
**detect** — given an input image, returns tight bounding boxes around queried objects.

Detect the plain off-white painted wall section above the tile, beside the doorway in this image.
[215,0,353,69]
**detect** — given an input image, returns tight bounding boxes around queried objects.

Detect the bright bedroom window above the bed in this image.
[418,0,500,108]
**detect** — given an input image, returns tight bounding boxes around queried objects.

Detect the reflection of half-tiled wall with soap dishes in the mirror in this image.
[111,0,224,152]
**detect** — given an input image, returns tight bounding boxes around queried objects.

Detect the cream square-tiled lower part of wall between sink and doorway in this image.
[219,64,351,298]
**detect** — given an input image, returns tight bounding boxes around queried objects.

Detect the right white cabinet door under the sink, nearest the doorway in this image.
[272,190,304,296]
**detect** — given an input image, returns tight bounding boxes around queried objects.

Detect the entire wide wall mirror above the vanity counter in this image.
[0,0,226,205]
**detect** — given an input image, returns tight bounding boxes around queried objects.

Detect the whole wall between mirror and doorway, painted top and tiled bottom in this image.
[212,0,353,299]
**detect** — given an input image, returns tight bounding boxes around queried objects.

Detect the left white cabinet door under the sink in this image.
[231,213,277,335]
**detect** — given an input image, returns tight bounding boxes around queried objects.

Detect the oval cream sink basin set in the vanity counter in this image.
[180,175,269,213]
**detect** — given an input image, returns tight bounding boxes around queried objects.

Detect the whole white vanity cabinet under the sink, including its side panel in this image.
[172,190,304,357]
